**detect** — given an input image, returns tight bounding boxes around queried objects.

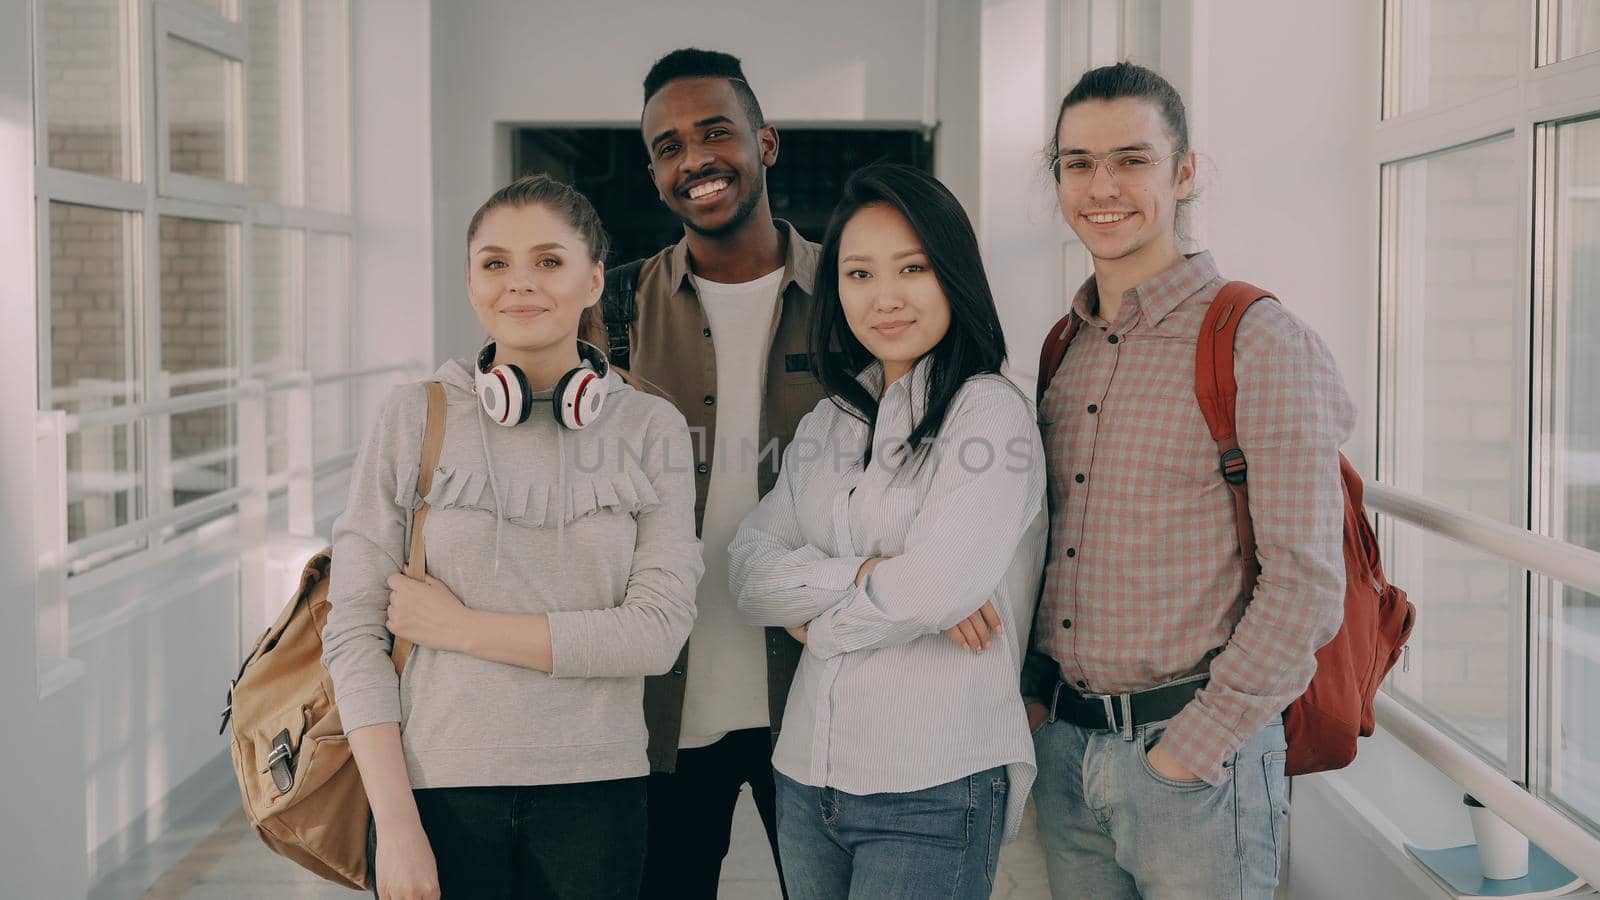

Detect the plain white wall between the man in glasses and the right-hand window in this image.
[1179,0,1382,474]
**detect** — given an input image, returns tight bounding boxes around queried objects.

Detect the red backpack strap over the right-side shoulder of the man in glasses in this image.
[1195,282,1278,588]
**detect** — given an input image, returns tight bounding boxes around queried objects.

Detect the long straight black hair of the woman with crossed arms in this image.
[811,163,1006,463]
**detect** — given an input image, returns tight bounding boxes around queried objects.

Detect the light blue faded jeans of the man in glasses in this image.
[1034,719,1290,900]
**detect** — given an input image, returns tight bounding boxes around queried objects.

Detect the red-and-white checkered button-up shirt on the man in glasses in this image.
[1034,253,1355,785]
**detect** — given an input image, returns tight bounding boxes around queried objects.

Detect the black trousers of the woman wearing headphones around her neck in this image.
[368,778,645,900]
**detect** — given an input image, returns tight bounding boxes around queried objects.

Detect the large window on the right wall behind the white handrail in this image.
[1378,0,1600,830]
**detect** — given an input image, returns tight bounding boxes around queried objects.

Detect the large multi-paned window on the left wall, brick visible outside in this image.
[34,0,354,578]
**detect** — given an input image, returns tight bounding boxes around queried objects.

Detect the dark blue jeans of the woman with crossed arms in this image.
[774,765,1010,900]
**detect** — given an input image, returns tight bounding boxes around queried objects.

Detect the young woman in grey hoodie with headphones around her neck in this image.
[323,176,702,900]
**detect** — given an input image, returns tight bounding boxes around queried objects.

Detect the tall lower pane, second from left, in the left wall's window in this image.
[155,216,237,506]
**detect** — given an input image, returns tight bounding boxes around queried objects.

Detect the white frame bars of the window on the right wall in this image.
[1373,0,1600,834]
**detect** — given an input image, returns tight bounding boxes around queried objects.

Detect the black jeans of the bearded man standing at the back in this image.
[640,729,787,900]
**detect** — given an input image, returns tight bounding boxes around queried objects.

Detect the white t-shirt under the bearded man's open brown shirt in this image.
[678,269,784,749]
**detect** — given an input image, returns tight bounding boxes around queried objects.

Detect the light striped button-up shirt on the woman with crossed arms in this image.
[728,359,1046,839]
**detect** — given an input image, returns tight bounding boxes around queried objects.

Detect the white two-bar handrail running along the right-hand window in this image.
[1365,482,1600,886]
